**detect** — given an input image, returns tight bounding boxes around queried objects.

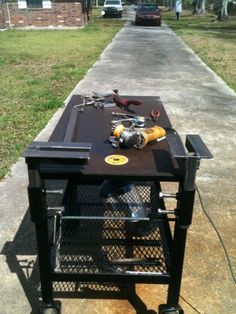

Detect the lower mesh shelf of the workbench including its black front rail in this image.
[52,182,170,283]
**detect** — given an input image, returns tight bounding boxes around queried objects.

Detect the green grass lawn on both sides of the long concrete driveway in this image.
[0,8,236,179]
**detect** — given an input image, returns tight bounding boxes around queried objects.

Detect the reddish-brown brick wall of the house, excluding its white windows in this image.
[0,2,84,28]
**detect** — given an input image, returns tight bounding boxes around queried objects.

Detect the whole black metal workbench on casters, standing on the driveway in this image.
[25,95,211,313]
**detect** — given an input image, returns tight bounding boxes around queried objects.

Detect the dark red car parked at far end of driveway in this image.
[135,3,161,26]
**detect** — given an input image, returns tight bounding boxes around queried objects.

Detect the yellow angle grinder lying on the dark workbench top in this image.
[109,121,166,149]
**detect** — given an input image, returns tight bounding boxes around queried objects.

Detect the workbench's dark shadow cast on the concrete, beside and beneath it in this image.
[0,210,157,314]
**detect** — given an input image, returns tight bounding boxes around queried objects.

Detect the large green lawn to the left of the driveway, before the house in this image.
[0,16,124,179]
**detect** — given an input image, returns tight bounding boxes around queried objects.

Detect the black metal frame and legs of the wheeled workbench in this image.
[25,97,212,314]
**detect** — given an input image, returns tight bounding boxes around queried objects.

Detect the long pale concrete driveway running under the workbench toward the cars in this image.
[0,7,236,314]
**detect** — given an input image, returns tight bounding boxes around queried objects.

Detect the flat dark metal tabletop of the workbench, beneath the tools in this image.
[50,95,182,179]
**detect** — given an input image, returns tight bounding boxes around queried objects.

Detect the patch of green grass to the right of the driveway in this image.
[163,11,236,91]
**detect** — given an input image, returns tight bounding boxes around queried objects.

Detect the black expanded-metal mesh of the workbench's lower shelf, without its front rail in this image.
[56,183,170,274]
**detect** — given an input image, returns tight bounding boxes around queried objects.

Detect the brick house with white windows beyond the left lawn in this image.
[0,0,88,29]
